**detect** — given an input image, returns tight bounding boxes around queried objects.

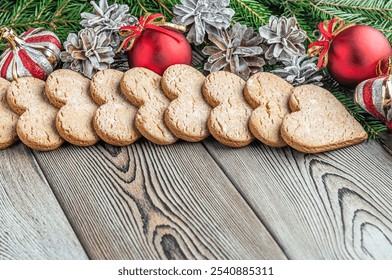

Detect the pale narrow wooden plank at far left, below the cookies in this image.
[0,144,87,260]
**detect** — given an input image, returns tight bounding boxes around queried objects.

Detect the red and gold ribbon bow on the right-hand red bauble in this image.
[308,18,355,68]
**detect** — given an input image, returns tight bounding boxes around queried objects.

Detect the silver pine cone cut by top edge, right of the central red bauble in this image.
[173,0,234,45]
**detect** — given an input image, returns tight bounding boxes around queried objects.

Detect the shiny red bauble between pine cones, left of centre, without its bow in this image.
[128,27,192,75]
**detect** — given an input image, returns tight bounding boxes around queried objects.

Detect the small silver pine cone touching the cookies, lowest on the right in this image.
[271,55,323,86]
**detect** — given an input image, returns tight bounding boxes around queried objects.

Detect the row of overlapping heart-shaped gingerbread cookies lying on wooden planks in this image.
[1,65,366,152]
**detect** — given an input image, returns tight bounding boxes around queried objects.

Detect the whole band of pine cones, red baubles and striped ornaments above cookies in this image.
[0,0,392,140]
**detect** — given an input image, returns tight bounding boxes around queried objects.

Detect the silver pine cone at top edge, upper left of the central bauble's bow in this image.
[80,0,137,50]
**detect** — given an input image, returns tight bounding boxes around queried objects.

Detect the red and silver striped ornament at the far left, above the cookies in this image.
[0,27,61,81]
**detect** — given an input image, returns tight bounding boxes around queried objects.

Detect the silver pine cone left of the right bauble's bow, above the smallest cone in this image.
[259,16,306,64]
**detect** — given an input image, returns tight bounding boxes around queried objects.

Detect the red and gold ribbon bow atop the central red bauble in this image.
[118,14,186,51]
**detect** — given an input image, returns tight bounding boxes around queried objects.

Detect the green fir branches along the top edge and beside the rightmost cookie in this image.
[0,0,392,140]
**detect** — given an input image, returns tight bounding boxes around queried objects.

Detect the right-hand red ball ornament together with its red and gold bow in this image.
[309,19,392,87]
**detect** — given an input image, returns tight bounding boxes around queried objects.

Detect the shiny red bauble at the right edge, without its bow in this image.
[327,25,392,87]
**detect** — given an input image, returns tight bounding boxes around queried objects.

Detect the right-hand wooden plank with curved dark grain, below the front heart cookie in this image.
[205,140,392,259]
